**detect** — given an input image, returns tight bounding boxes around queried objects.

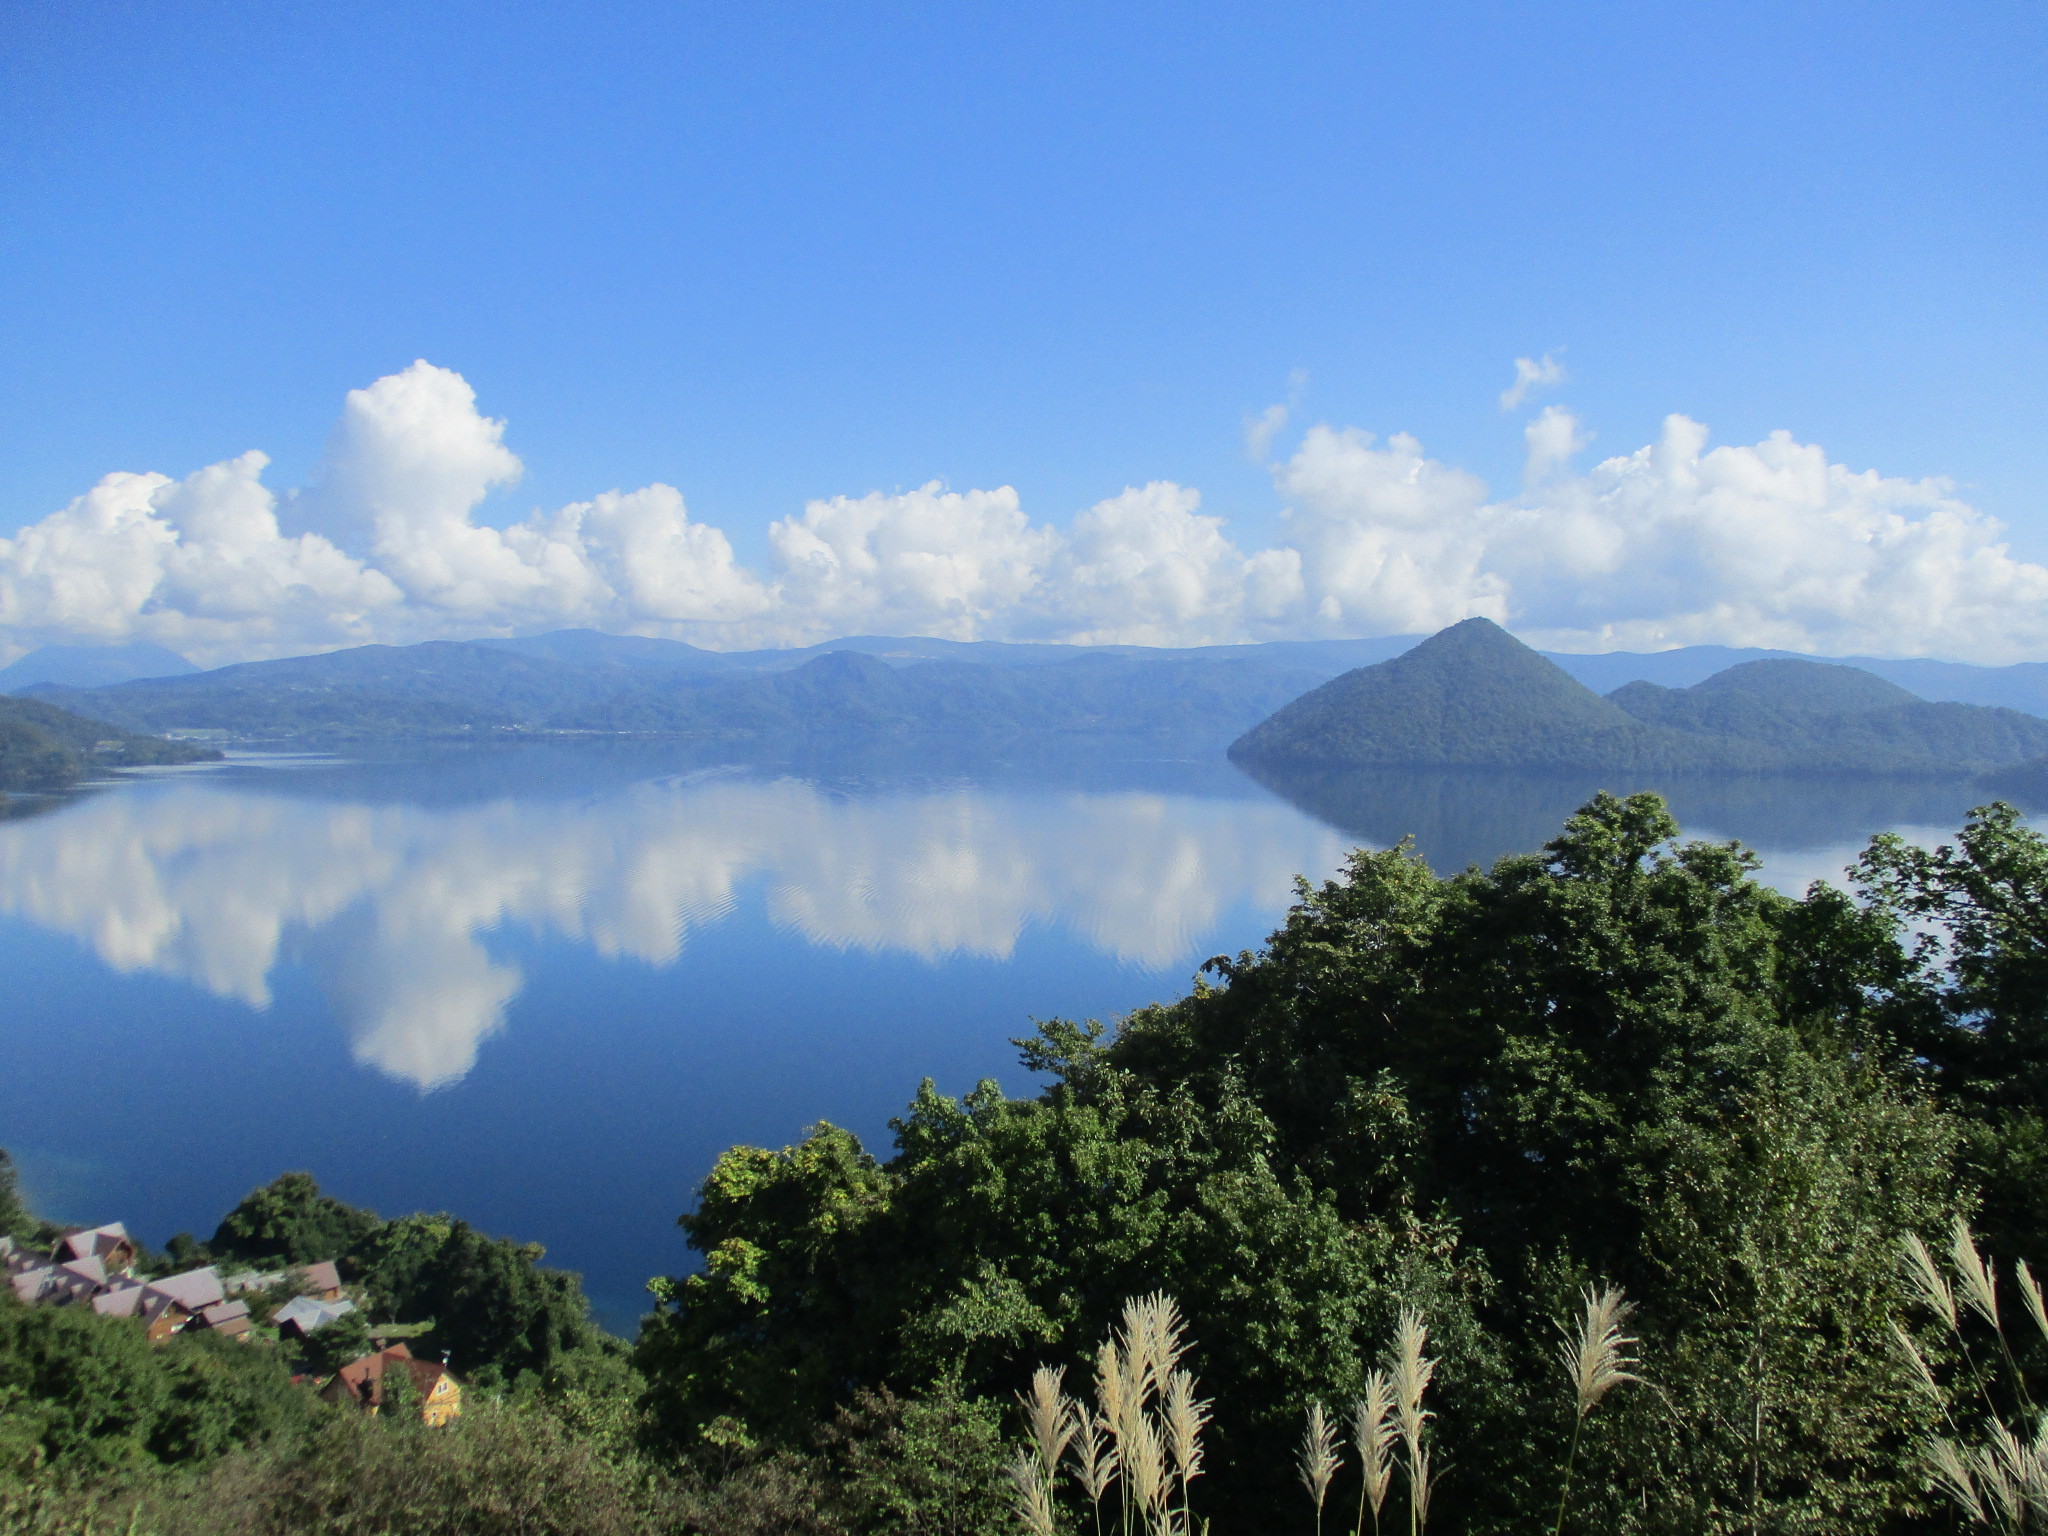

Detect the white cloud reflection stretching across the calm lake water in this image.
[0,778,1348,1090]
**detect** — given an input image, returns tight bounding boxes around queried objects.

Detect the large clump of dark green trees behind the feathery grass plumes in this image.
[639,795,1990,1532]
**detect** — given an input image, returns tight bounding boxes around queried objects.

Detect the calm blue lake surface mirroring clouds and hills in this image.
[0,745,1985,1329]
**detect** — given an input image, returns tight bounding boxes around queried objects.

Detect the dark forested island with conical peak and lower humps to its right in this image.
[1231,618,2048,774]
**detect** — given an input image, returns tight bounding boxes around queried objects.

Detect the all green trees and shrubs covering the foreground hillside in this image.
[12,795,2048,1536]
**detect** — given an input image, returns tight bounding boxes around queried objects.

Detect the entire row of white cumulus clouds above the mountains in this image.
[0,366,2048,664]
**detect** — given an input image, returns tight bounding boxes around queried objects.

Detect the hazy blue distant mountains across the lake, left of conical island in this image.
[37,637,1327,750]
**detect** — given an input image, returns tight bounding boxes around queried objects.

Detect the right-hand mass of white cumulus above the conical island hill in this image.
[1280,412,2048,662]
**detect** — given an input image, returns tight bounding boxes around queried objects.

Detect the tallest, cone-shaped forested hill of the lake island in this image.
[1231,618,1698,770]
